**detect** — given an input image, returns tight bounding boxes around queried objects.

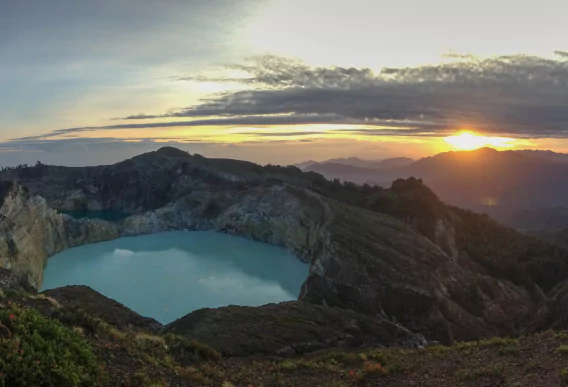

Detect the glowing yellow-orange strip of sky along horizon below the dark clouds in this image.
[30,125,568,164]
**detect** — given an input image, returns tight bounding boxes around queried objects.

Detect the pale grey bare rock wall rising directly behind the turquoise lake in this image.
[120,184,331,262]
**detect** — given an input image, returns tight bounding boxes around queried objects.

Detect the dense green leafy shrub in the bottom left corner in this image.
[0,305,102,387]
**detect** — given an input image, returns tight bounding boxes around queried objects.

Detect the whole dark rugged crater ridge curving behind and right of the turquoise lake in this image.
[0,148,568,345]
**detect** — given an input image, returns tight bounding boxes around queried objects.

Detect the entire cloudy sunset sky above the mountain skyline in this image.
[0,0,568,165]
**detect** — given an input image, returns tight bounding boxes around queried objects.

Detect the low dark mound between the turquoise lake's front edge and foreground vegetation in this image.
[166,302,426,356]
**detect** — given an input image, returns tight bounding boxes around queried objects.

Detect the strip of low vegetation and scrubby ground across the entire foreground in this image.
[0,292,568,387]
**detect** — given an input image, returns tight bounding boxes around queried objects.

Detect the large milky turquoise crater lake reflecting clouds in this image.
[41,231,308,324]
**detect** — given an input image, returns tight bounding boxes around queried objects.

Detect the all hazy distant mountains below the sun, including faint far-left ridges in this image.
[305,148,568,229]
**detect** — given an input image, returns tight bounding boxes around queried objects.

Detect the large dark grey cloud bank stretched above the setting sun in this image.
[121,51,568,138]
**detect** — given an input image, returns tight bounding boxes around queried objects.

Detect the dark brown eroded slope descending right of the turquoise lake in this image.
[300,204,544,343]
